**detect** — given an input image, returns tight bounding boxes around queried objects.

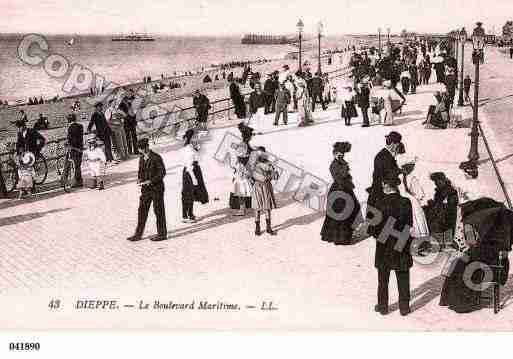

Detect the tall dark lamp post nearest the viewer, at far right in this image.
[460,22,485,178]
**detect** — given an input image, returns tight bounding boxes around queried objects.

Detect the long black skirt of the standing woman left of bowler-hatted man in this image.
[321,183,362,245]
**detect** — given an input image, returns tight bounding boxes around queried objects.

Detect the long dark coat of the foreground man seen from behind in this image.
[374,193,413,271]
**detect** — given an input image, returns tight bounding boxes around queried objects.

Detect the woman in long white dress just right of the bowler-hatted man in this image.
[400,160,429,239]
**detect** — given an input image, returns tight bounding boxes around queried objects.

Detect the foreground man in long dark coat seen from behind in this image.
[374,175,413,316]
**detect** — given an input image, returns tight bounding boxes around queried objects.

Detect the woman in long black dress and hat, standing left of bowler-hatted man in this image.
[321,142,361,245]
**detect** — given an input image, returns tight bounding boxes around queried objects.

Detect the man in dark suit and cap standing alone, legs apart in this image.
[127,138,167,242]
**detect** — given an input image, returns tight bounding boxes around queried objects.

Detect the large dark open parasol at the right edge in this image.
[461,198,513,251]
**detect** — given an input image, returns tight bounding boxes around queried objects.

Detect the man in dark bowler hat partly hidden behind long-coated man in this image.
[367,131,405,237]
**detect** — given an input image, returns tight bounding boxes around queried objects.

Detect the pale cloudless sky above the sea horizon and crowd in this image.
[0,0,513,35]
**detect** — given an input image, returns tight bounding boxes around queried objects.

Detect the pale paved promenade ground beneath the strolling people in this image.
[0,66,513,331]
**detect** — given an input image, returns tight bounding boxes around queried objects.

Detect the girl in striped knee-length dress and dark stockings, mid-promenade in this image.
[250,147,278,236]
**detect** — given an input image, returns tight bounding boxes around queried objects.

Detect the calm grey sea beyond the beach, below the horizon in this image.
[0,34,353,103]
